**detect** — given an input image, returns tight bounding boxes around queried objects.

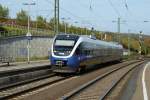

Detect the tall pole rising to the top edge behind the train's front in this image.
[54,0,59,34]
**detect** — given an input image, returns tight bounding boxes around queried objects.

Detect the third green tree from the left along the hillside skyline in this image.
[36,16,47,28]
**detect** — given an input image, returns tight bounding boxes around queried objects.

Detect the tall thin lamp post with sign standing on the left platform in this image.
[23,3,35,64]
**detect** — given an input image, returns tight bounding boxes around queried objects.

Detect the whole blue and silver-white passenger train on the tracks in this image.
[50,34,123,73]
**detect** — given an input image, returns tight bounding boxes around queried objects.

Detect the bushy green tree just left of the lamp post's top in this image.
[17,10,28,26]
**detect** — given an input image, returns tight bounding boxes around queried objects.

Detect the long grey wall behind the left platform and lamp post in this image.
[0,36,52,61]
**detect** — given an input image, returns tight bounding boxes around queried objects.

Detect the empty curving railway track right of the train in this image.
[60,61,144,100]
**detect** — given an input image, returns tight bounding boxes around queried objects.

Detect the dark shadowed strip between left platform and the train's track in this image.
[0,66,52,90]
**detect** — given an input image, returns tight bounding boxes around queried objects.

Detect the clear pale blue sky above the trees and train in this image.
[0,0,150,35]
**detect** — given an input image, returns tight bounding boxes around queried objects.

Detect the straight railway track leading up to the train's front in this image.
[0,74,68,100]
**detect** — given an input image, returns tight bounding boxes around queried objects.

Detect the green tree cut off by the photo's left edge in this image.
[0,5,9,22]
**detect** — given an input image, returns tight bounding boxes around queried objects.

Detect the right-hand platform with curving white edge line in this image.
[121,61,150,100]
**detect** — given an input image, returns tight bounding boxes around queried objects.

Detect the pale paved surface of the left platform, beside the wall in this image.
[0,60,50,73]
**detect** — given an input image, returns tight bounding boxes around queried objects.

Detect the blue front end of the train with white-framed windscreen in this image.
[50,35,79,73]
